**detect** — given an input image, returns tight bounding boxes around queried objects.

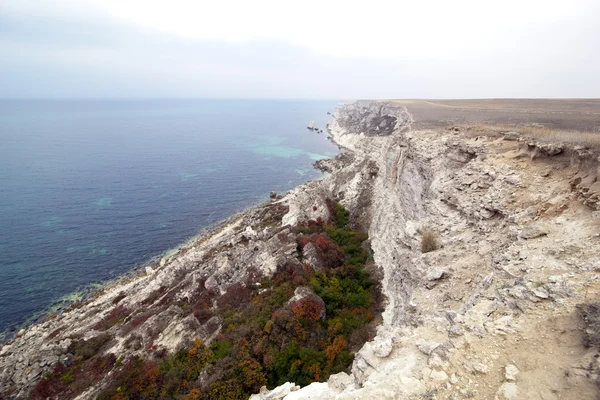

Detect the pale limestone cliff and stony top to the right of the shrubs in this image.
[257,102,600,399]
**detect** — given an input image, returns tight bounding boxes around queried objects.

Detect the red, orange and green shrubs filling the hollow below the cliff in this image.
[34,201,379,399]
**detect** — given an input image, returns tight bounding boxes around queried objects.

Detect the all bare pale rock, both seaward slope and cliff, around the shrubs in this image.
[0,102,600,399]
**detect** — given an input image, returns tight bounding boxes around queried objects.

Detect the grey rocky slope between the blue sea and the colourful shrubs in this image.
[0,201,302,399]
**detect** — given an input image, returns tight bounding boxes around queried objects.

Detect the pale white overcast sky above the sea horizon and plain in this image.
[0,0,600,99]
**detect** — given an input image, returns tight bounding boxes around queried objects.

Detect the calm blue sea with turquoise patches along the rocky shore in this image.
[0,100,338,338]
